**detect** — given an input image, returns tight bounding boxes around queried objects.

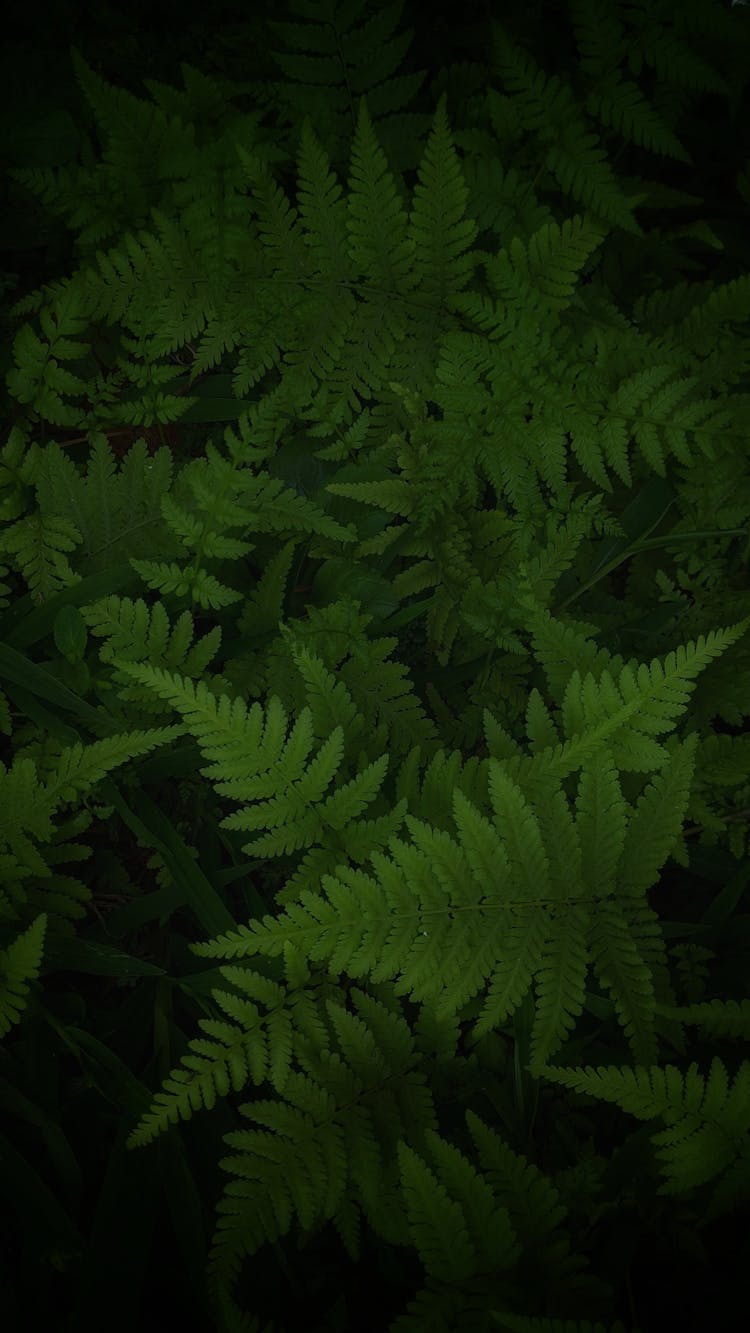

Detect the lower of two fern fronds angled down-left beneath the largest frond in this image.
[209,989,438,1282]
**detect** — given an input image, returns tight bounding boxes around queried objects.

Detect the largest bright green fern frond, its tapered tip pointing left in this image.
[182,645,714,1064]
